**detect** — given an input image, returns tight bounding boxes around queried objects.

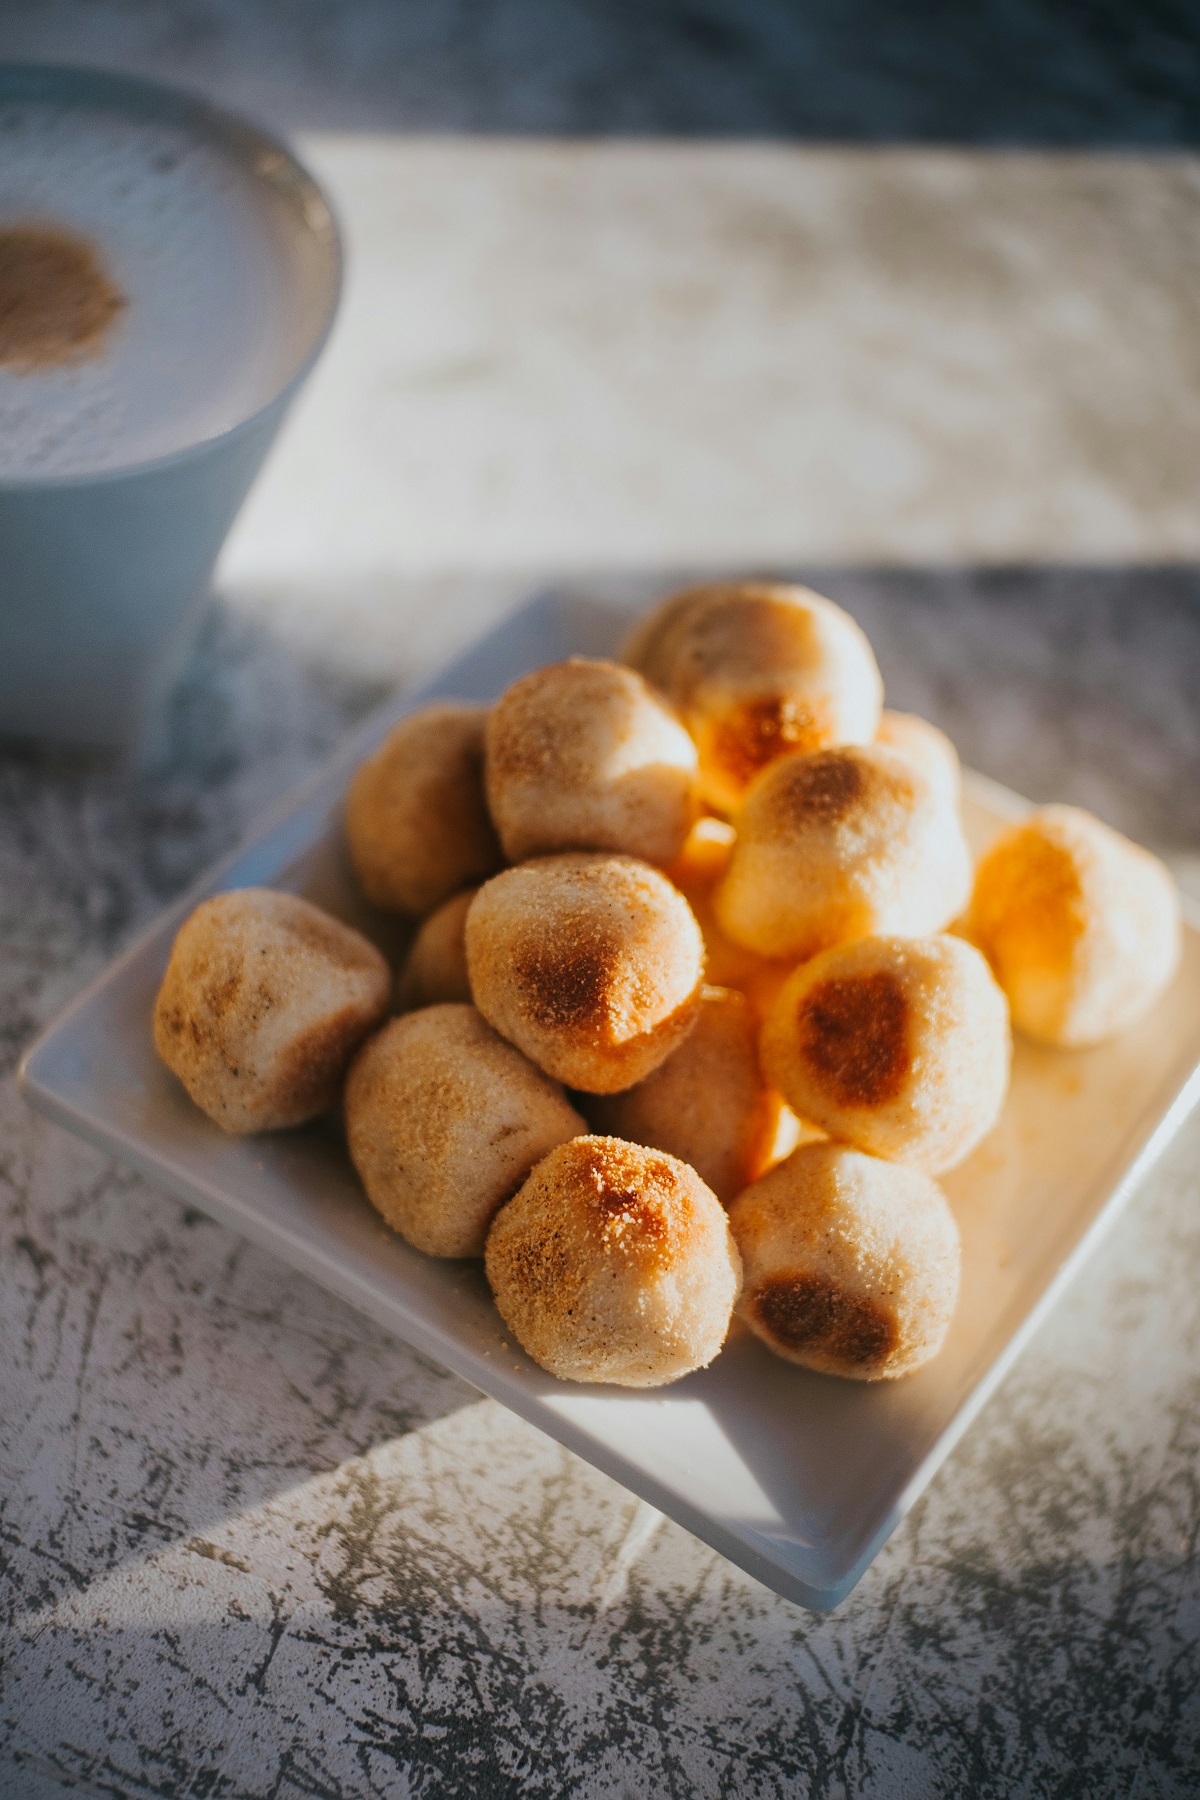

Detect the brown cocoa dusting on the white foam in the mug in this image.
[0,225,128,374]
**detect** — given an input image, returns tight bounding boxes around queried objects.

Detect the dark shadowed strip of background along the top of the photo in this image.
[0,0,1200,146]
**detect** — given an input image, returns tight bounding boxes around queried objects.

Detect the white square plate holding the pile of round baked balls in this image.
[22,599,1200,1607]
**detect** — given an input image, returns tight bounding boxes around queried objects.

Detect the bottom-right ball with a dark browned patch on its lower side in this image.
[729,1143,963,1381]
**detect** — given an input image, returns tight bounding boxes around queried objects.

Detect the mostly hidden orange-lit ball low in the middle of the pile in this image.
[585,986,783,1206]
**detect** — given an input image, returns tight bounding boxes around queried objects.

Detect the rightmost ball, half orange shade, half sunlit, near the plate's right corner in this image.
[966,806,1180,1049]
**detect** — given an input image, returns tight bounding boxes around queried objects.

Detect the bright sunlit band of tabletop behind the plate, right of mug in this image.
[208,135,1200,590]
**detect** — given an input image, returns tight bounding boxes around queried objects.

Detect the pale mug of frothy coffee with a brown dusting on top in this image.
[0,65,340,745]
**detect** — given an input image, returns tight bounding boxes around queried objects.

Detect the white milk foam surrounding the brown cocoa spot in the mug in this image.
[0,99,329,481]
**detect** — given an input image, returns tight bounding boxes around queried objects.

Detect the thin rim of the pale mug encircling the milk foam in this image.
[0,61,345,493]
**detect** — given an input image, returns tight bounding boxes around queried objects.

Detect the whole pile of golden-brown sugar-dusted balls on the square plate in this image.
[155,583,1180,1386]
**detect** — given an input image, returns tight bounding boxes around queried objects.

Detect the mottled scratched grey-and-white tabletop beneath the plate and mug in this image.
[0,0,1200,1800]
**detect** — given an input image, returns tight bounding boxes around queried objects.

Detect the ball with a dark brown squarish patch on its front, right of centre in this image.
[761,938,1011,1175]
